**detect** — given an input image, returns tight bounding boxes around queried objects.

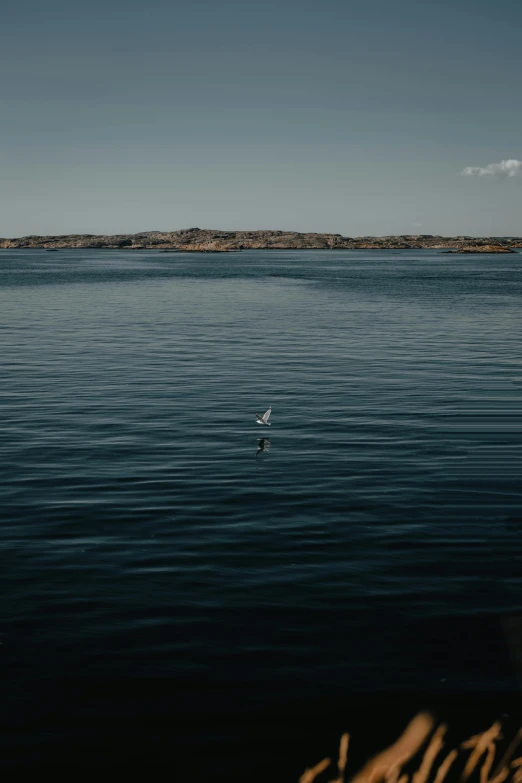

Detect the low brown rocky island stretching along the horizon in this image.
[0,228,522,253]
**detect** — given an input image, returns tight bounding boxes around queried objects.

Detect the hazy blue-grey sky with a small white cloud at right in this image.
[0,0,522,237]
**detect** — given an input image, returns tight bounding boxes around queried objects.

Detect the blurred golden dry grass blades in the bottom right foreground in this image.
[299,712,522,783]
